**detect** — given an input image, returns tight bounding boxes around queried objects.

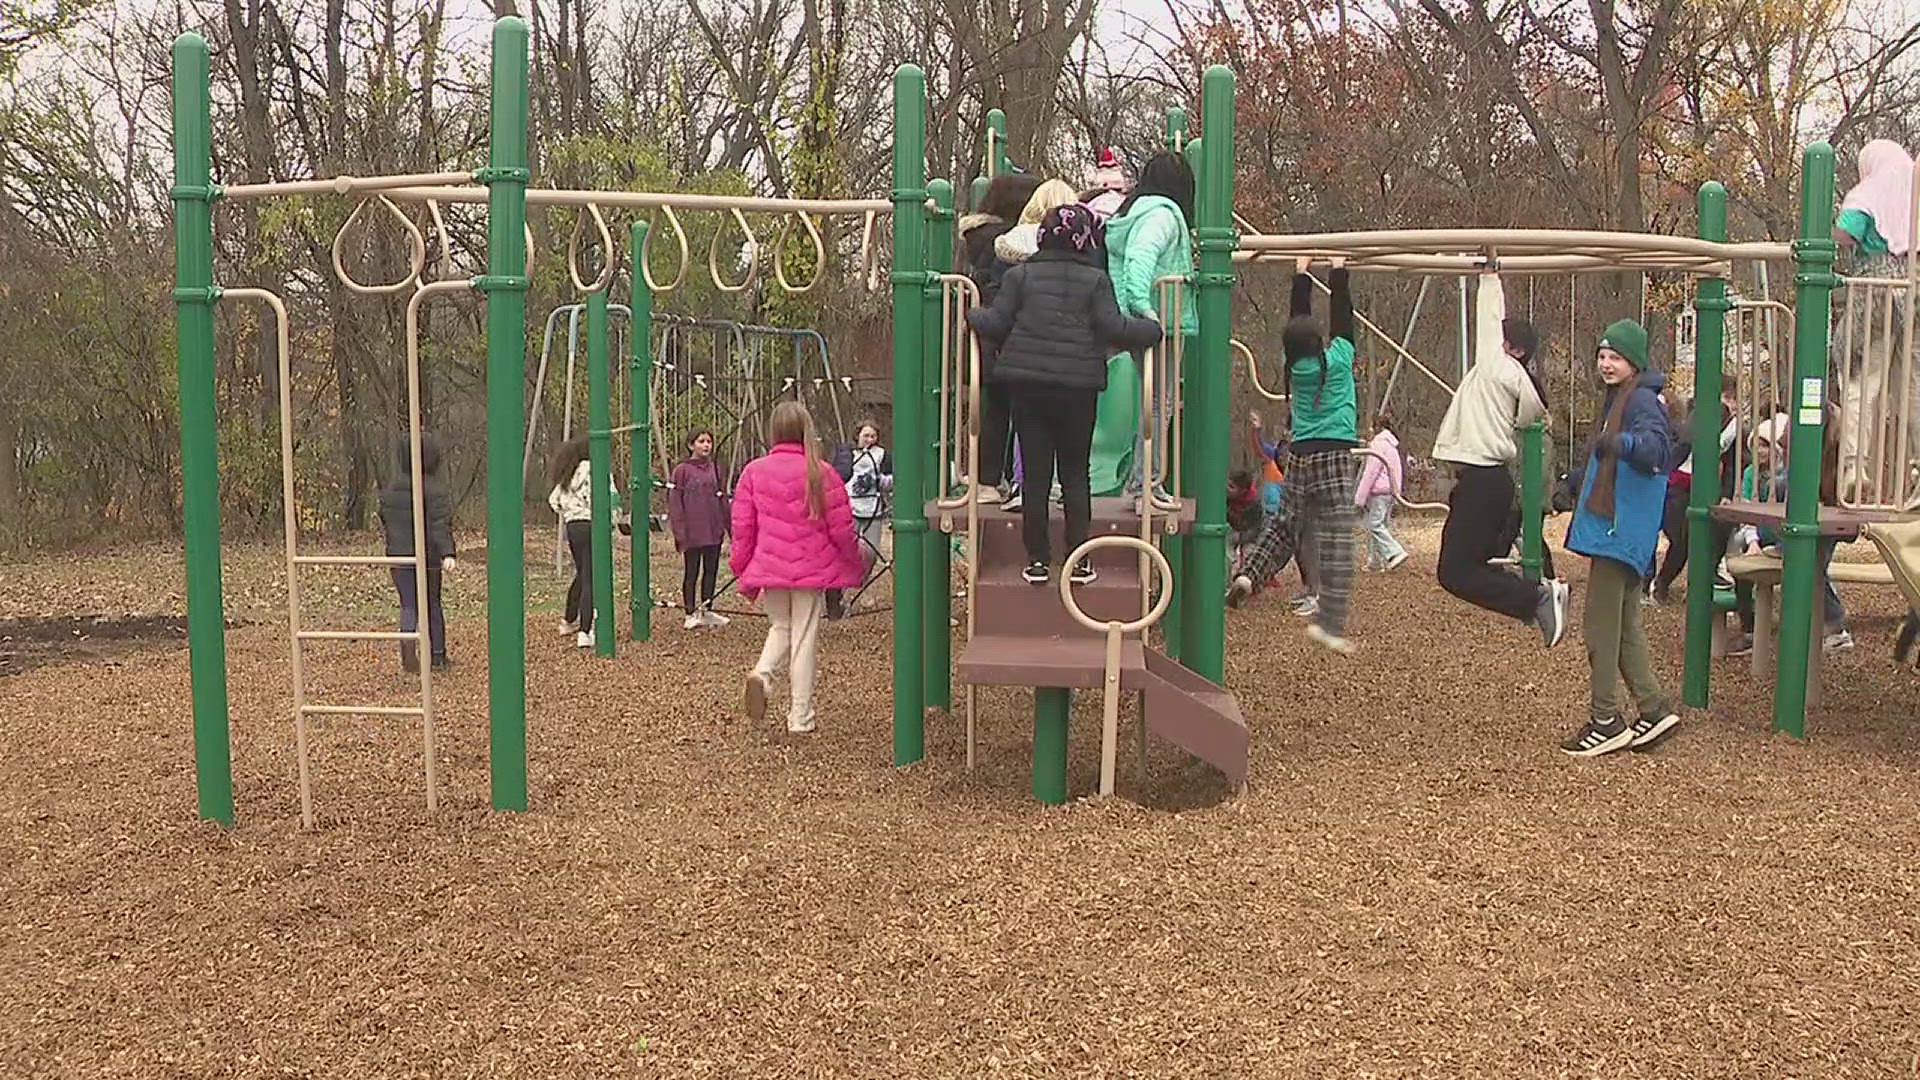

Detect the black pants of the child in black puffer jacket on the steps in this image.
[1012,386,1100,565]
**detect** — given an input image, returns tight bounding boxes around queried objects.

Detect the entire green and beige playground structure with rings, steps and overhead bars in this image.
[173,17,1916,824]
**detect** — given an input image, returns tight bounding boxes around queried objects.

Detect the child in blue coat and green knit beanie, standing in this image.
[1561,319,1680,757]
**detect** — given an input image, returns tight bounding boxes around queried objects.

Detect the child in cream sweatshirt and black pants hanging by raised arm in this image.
[1434,273,1569,648]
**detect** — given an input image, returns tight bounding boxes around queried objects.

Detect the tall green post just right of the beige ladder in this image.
[474,15,530,811]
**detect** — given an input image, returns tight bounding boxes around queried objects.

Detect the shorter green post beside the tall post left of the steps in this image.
[921,181,952,709]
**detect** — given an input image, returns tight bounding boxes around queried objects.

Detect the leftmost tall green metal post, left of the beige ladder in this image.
[173,33,234,826]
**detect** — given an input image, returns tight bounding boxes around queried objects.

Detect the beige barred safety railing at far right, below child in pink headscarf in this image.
[1834,275,1920,511]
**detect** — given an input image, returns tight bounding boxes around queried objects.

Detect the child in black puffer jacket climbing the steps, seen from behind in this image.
[968,202,1160,584]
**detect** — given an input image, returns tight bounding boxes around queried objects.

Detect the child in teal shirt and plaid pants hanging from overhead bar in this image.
[1227,259,1359,653]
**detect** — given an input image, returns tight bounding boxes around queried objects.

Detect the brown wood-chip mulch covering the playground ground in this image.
[0,523,1920,1078]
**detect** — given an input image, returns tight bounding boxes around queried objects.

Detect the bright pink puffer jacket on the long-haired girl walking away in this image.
[730,442,862,600]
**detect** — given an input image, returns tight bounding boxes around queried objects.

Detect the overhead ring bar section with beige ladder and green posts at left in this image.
[173,17,890,824]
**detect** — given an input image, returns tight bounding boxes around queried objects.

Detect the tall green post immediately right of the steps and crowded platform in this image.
[1181,65,1238,682]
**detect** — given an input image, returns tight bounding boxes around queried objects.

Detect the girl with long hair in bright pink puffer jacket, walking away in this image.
[730,402,862,734]
